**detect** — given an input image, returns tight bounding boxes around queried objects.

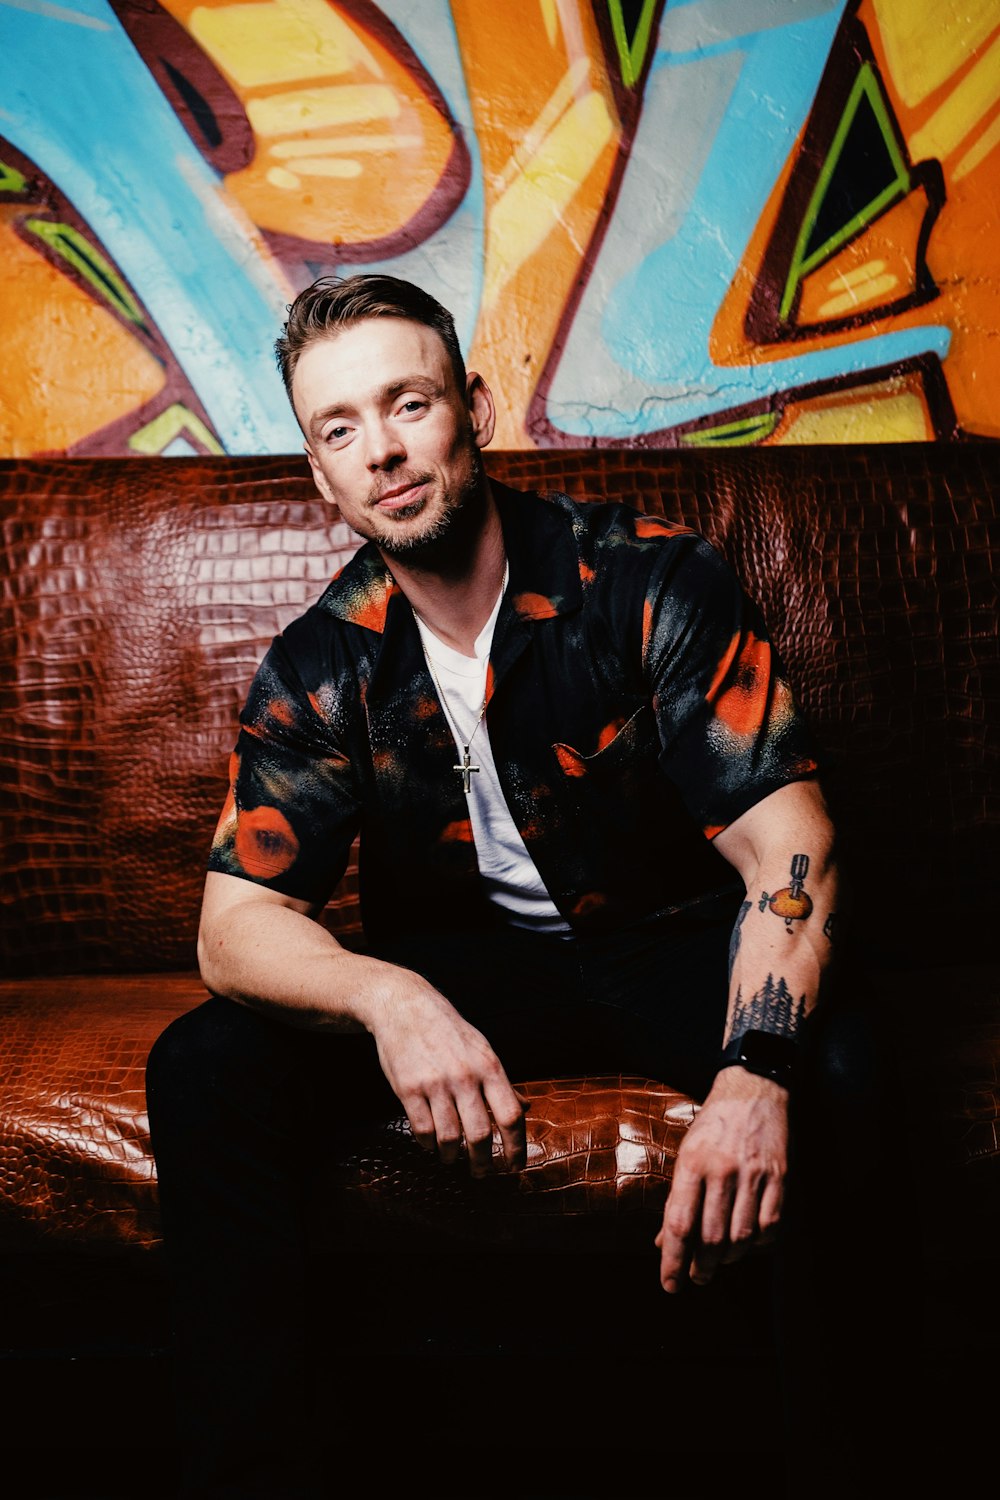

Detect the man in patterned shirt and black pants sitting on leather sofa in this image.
[147,276,881,1497]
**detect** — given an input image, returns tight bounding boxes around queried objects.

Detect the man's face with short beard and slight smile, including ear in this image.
[292,318,493,558]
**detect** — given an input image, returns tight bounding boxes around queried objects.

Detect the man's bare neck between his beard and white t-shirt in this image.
[387,494,507,657]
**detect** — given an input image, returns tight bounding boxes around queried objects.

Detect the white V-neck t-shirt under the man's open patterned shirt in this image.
[417,590,570,933]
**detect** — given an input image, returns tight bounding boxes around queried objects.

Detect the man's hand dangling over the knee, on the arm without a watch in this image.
[369,969,528,1178]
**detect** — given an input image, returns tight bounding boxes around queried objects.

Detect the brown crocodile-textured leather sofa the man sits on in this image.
[0,443,1000,1482]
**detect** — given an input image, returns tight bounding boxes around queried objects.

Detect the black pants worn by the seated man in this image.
[147,912,917,1500]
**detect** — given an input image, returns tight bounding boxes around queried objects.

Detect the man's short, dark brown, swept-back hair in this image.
[274,273,465,401]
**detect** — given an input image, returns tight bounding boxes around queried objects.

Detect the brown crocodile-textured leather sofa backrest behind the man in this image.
[0,444,1000,975]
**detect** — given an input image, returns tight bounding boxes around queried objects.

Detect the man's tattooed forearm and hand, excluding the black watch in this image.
[657,782,840,1292]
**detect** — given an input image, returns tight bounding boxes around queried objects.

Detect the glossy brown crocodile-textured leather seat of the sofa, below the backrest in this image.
[0,965,1000,1251]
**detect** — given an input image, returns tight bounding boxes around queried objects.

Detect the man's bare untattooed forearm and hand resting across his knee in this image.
[198,872,526,1176]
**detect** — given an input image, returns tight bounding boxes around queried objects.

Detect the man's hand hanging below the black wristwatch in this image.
[655,1068,789,1292]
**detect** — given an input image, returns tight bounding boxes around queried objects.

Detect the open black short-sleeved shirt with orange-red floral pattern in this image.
[210,482,817,939]
